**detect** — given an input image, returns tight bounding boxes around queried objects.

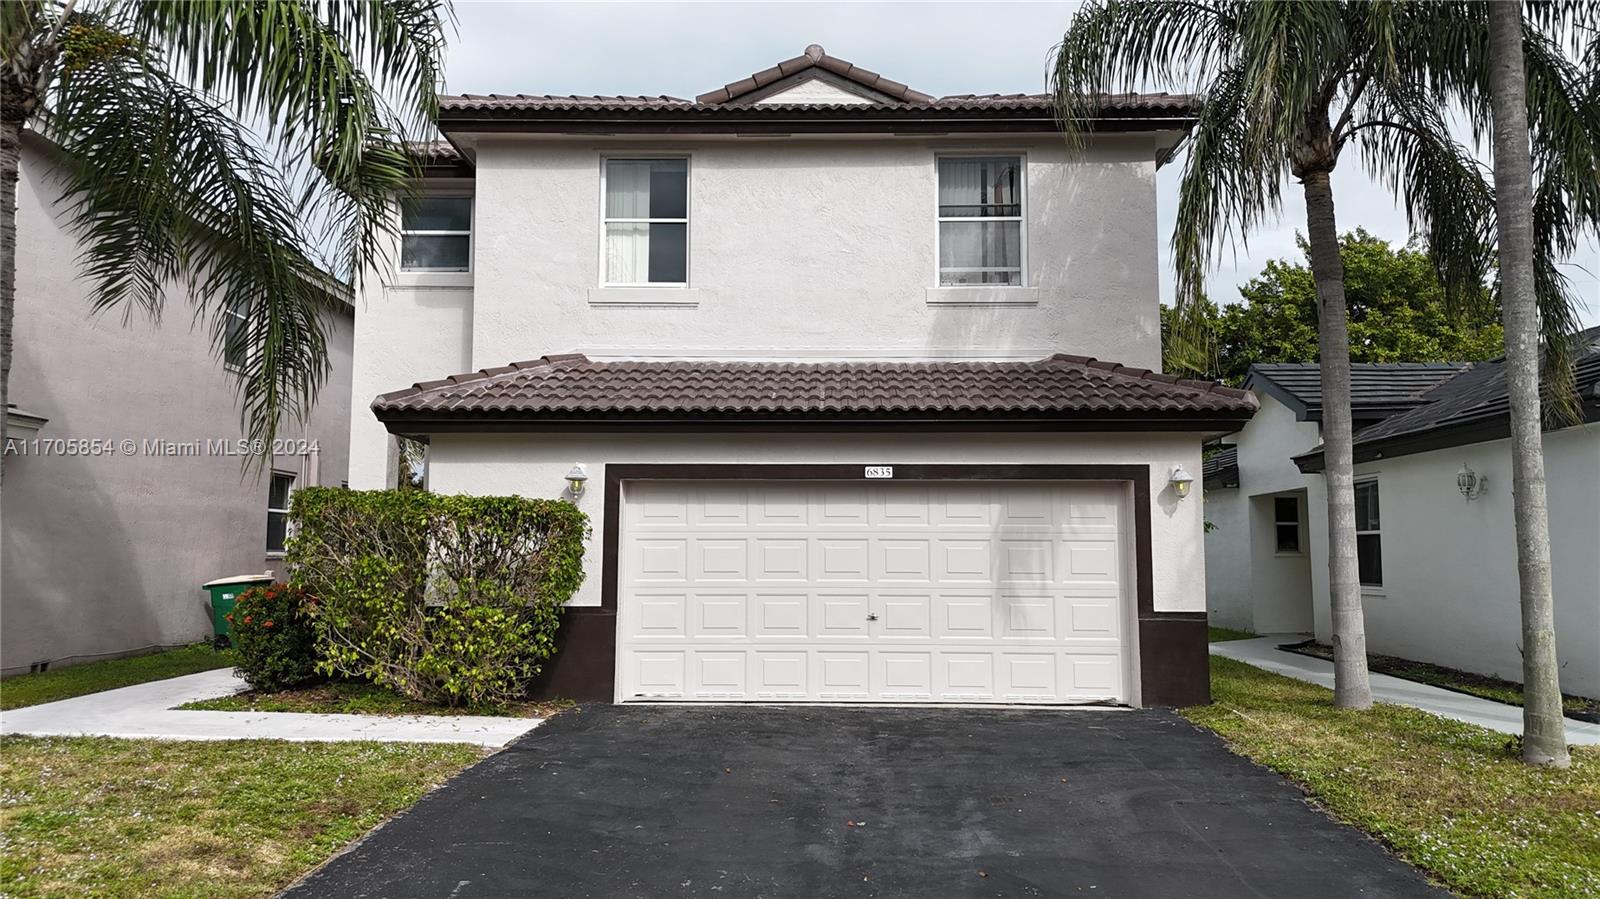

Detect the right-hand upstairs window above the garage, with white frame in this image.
[939,157,1022,286]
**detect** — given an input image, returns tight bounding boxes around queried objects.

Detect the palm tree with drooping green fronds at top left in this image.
[0,0,450,483]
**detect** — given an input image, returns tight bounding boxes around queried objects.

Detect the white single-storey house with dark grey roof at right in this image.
[1205,335,1600,696]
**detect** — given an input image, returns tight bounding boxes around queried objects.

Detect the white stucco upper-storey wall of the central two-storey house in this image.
[350,134,1160,488]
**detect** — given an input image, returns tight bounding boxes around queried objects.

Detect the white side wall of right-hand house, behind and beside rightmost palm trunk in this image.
[1312,426,1600,696]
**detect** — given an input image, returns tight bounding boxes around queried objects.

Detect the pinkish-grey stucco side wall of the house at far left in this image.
[0,134,354,673]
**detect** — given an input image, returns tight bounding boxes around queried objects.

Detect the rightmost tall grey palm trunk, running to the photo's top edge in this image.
[1490,3,1571,768]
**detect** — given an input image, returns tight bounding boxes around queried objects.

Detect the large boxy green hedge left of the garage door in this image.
[286,488,589,705]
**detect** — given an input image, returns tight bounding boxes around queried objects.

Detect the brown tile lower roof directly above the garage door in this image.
[373,354,1256,429]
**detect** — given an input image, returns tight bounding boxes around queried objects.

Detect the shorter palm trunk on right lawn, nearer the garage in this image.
[1301,170,1373,709]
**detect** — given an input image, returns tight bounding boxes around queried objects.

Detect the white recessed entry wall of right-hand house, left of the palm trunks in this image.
[1206,390,1326,633]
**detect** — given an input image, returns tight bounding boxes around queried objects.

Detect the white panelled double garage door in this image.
[618,481,1131,702]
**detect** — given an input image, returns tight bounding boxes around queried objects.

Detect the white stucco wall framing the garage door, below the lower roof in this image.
[429,432,1205,611]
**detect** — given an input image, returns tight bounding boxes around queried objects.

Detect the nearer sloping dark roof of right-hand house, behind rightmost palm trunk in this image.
[1294,328,1600,472]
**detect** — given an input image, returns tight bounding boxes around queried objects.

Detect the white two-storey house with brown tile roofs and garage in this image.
[350,46,1256,704]
